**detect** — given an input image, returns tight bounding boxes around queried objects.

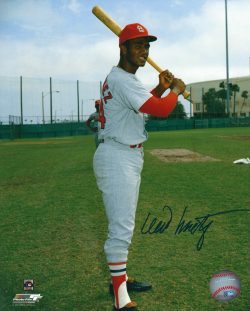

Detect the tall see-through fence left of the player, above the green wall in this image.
[0,77,100,124]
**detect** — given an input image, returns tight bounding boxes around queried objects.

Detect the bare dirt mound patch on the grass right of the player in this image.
[150,149,219,162]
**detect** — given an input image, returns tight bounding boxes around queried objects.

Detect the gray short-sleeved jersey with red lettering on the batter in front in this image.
[99,67,152,145]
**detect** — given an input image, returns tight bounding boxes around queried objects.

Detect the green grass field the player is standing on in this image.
[0,128,250,311]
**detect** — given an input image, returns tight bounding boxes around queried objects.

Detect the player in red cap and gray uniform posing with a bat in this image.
[93,23,185,311]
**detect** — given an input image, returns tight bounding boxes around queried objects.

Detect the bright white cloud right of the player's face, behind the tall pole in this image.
[143,0,250,83]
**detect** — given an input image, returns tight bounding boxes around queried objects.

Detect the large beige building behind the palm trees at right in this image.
[187,76,250,117]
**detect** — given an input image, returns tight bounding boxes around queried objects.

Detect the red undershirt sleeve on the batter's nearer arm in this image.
[139,92,178,118]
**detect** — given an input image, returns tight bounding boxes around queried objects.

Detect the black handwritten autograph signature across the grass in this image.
[141,205,250,251]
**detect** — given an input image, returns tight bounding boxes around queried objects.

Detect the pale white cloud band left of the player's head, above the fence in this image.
[0,36,119,81]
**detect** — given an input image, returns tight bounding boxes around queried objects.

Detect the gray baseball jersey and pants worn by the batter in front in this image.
[93,67,152,262]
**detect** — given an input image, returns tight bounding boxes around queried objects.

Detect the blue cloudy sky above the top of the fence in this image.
[0,0,250,120]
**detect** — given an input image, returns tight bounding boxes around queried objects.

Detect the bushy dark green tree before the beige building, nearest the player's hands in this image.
[202,88,225,117]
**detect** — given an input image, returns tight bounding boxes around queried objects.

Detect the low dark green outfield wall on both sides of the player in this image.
[0,117,250,139]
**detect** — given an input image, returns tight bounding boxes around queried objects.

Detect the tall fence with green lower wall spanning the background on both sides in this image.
[0,76,250,138]
